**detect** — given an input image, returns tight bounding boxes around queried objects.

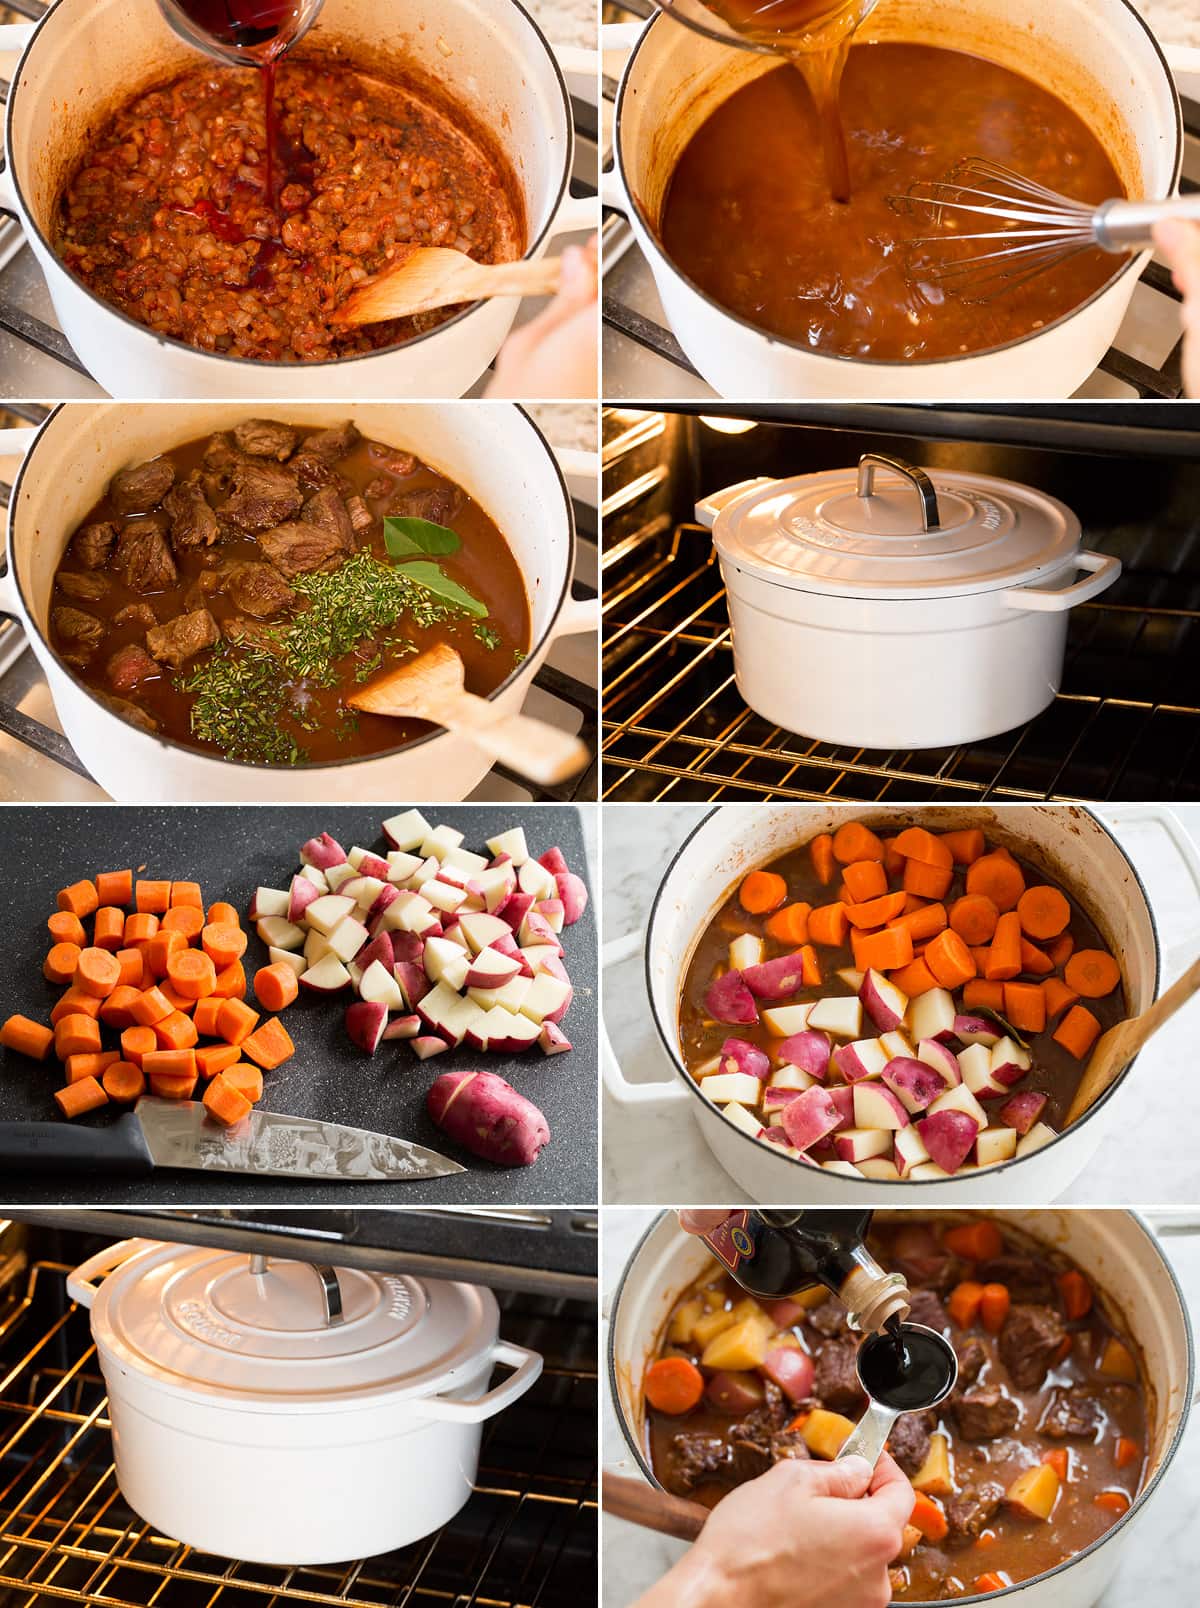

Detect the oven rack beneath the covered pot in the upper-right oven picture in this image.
[600,518,1200,804]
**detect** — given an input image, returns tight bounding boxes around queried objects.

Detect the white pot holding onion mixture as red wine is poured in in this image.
[0,0,597,402]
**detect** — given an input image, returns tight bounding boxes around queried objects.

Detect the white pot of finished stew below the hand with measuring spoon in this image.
[608,1211,1195,1608]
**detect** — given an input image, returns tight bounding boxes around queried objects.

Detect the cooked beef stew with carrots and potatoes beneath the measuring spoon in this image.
[645,1214,1147,1602]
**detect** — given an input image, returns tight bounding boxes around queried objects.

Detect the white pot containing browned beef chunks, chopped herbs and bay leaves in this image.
[0,402,598,804]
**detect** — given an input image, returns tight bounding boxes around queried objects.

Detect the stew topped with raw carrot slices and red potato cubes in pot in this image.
[679,822,1126,1182]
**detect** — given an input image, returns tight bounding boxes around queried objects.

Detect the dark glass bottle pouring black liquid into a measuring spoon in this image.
[703,1208,909,1335]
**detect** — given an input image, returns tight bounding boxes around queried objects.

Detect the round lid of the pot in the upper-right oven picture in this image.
[698,453,1081,598]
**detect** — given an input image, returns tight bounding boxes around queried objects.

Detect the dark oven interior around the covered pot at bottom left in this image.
[0,1209,597,1608]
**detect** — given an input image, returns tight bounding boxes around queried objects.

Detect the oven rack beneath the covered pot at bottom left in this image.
[0,1261,597,1608]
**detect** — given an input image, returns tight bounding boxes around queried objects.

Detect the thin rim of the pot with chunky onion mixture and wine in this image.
[5,0,574,376]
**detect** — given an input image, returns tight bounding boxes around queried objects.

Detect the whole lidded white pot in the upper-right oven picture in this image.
[697,453,1121,749]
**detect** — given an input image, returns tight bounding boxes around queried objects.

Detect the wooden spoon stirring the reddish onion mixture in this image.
[331,246,561,323]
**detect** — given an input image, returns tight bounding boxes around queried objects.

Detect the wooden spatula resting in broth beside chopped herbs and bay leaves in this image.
[347,643,587,786]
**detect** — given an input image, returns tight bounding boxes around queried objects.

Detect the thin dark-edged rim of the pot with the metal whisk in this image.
[613,0,1184,375]
